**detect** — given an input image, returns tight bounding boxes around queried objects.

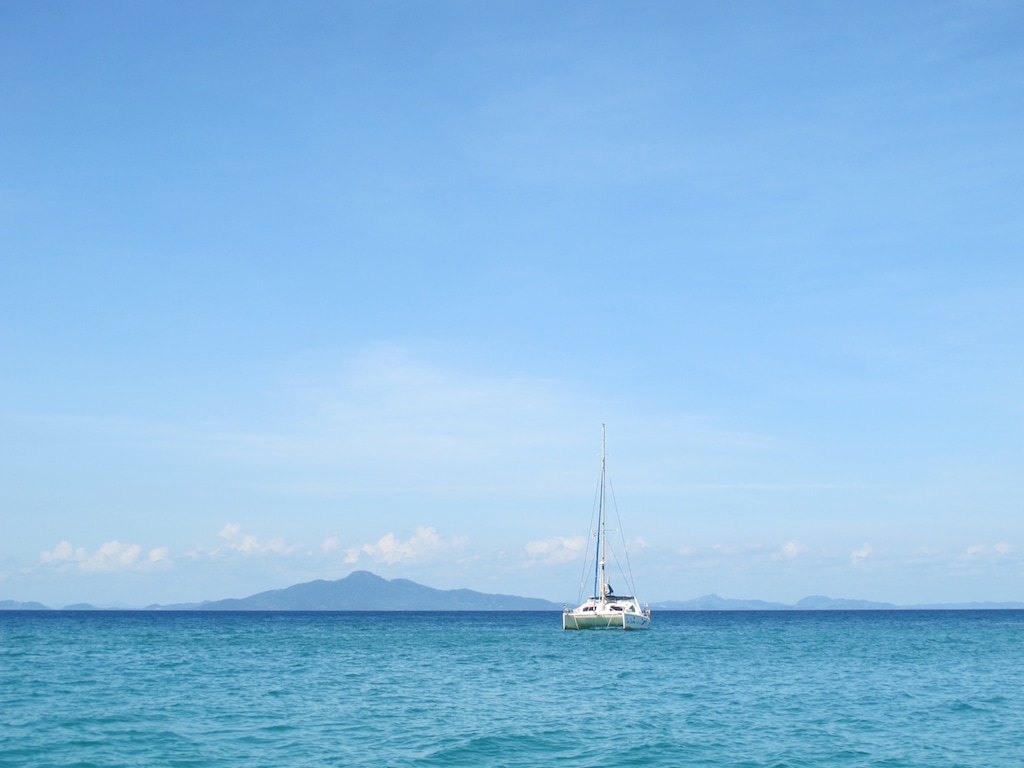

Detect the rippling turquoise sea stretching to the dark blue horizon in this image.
[0,611,1024,768]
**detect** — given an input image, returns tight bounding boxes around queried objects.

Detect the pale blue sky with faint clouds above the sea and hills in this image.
[0,0,1024,607]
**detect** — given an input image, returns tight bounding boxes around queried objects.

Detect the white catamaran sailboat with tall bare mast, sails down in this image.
[562,424,650,630]
